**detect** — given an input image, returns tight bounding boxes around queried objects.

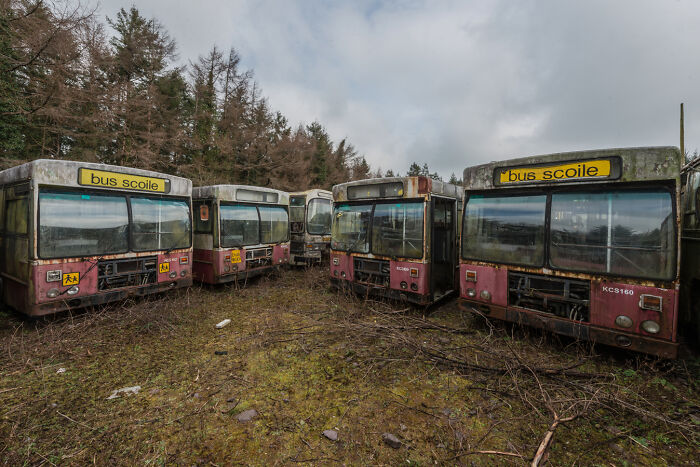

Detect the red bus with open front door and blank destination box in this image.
[330,177,462,305]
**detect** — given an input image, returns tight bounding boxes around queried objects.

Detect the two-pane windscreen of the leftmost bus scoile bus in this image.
[35,187,192,259]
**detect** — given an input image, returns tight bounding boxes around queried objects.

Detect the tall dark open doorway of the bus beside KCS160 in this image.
[430,197,457,299]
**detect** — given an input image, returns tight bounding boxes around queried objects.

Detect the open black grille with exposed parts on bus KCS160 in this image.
[508,272,591,322]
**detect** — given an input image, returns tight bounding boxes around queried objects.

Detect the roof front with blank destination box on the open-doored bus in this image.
[333,176,464,201]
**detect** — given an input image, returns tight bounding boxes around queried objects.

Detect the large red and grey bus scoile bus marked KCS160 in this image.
[459,147,681,358]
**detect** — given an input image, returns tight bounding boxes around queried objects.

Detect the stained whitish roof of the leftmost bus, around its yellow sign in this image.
[0,159,192,196]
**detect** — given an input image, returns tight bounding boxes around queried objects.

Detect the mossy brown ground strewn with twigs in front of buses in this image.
[0,269,700,466]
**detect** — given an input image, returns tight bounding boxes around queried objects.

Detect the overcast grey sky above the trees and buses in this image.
[99,0,700,177]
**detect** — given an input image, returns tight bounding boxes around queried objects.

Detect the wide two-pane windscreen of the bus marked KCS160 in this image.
[460,184,678,282]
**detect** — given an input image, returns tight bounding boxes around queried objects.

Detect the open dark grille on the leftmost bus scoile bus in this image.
[97,256,158,290]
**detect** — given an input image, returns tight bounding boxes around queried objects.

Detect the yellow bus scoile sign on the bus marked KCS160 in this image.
[498,159,611,185]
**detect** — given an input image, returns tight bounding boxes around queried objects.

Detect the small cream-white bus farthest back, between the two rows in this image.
[289,190,333,266]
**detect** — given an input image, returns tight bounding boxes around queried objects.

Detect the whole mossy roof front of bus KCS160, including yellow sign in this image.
[462,146,683,190]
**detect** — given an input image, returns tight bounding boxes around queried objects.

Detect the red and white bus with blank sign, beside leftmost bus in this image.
[192,185,289,284]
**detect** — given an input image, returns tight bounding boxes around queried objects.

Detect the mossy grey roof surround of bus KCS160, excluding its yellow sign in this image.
[462,146,683,190]
